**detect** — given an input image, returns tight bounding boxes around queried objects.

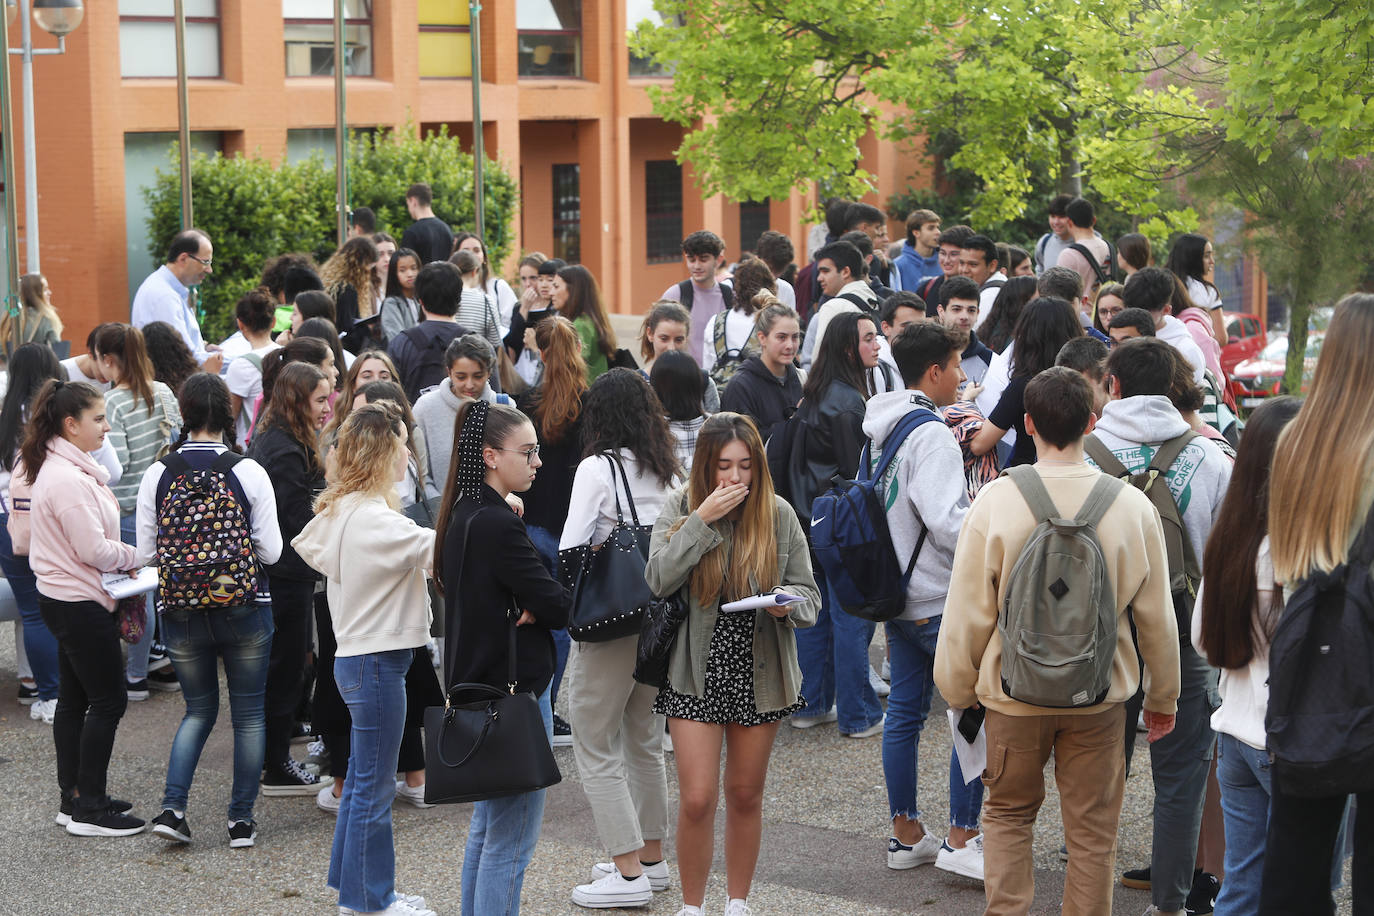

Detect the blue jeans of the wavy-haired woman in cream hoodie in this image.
[328,648,415,913]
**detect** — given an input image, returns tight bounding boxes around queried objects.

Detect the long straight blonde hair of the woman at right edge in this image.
[1270,293,1374,582]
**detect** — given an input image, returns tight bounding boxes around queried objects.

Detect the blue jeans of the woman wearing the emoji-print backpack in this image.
[162,604,272,821]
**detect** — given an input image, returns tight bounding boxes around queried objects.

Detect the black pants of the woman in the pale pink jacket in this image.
[38,593,129,812]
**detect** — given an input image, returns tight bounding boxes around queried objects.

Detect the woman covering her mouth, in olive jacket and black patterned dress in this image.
[644,413,820,916]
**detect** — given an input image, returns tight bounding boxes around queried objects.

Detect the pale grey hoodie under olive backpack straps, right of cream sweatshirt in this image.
[1088,395,1231,552]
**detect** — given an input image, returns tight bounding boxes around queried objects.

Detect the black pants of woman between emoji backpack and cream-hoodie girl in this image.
[264,575,315,768]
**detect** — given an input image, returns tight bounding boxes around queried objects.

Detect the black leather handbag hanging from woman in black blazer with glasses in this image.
[425,512,563,805]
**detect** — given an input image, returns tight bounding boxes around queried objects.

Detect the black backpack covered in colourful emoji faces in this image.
[157,452,258,611]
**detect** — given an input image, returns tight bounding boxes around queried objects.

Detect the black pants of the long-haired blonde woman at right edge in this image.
[1260,779,1374,916]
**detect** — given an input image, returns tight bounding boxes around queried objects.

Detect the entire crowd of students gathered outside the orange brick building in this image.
[0,185,1374,916]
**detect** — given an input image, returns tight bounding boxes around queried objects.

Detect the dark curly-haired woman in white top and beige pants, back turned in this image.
[558,369,680,908]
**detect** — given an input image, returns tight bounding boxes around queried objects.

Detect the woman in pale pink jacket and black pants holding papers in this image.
[19,380,144,836]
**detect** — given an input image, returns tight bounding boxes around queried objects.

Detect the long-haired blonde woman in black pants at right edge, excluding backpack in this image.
[1259,293,1374,916]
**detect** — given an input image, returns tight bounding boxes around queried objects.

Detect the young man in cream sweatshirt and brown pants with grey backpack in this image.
[934,367,1179,916]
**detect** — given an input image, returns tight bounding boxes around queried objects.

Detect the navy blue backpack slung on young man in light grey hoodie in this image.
[811,408,943,623]
